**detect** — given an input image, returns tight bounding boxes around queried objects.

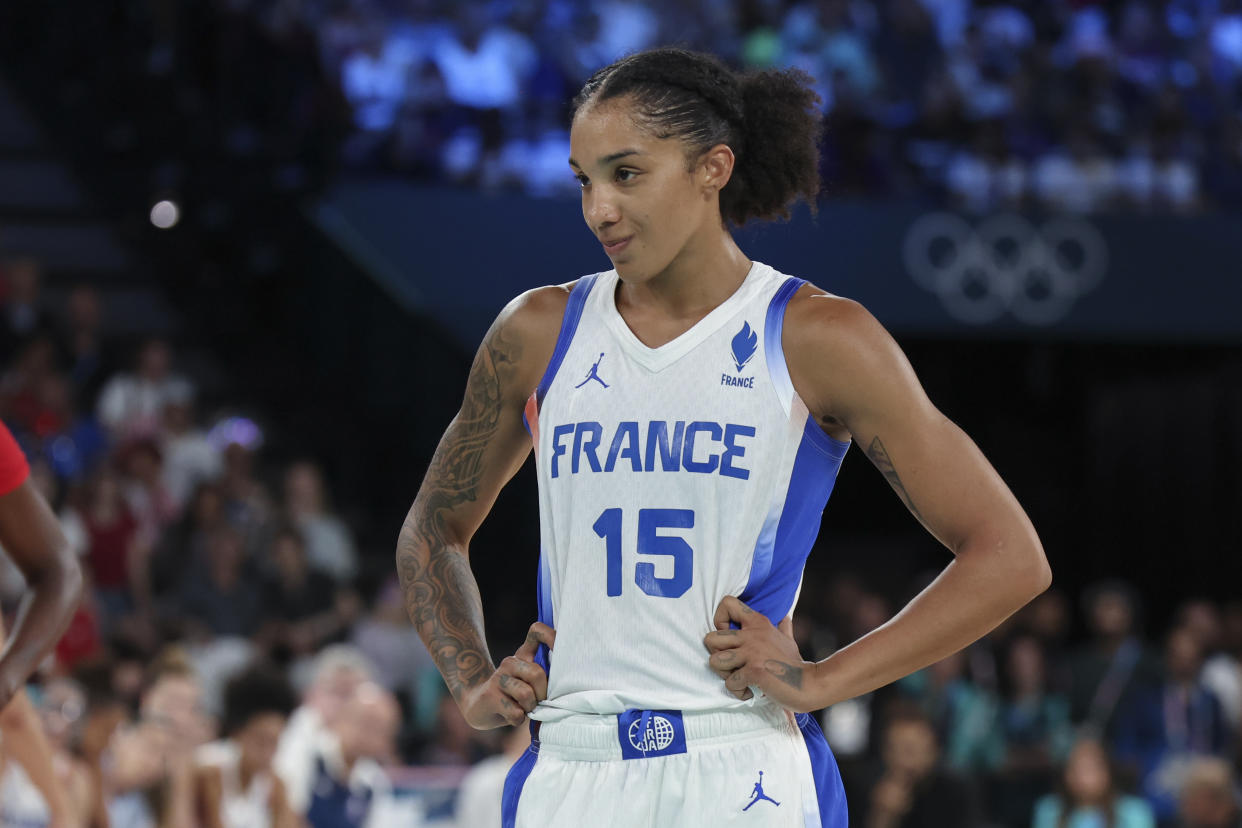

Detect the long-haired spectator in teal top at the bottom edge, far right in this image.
[1031,739,1156,828]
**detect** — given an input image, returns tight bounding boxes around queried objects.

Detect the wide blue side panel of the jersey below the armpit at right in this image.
[740,416,848,624]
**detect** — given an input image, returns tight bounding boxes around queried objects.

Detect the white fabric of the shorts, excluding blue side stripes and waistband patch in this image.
[517,705,822,828]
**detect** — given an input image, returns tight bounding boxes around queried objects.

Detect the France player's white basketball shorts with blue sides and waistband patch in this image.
[502,705,848,828]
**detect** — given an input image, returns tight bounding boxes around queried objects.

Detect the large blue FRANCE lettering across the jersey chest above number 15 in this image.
[551,420,755,480]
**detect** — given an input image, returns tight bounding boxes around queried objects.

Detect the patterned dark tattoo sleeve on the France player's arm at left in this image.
[396,322,520,699]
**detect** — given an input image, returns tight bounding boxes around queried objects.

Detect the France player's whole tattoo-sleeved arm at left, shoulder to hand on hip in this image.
[396,287,568,729]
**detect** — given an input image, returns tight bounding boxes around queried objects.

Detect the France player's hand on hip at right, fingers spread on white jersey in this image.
[703,595,821,713]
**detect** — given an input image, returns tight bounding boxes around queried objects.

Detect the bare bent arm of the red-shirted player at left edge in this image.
[0,479,82,708]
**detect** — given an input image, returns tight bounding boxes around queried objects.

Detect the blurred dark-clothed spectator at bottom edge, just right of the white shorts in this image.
[846,703,982,828]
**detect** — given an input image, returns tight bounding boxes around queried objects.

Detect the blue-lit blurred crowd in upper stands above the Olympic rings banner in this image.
[259,0,1242,212]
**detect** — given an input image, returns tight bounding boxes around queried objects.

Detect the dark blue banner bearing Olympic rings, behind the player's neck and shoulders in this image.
[312,180,1242,346]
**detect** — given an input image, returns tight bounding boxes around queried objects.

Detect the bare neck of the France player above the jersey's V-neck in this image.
[617,232,751,320]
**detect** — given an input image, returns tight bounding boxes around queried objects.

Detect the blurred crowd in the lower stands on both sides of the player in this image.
[0,249,1242,828]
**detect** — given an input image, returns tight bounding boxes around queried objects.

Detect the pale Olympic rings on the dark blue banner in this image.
[902,212,1108,325]
